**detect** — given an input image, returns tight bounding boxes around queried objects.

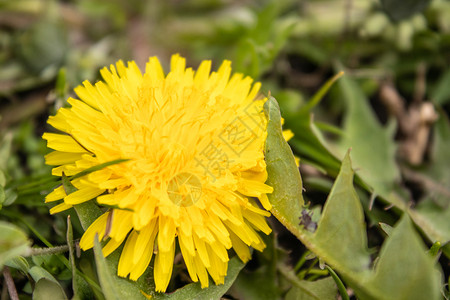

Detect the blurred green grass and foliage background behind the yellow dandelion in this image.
[0,0,450,299]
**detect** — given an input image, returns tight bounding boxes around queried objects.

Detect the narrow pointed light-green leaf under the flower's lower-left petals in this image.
[94,235,125,300]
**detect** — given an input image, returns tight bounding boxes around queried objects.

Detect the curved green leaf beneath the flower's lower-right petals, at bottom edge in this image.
[160,256,245,300]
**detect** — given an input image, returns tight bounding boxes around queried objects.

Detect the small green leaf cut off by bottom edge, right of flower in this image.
[285,274,337,300]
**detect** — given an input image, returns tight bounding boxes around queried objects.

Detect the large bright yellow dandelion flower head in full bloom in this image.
[43,55,272,291]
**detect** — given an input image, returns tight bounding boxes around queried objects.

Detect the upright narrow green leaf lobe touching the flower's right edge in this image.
[264,97,304,224]
